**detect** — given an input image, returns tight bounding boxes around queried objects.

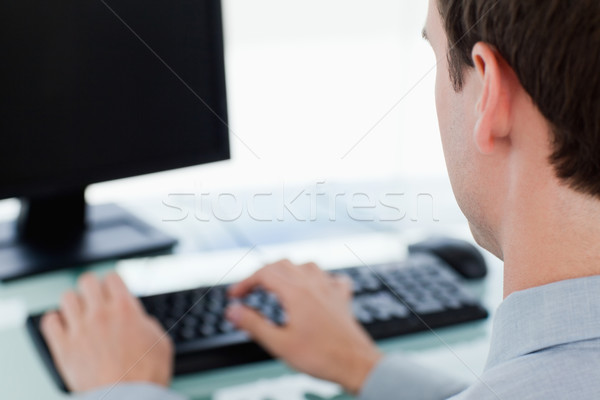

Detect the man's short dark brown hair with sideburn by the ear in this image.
[437,0,600,197]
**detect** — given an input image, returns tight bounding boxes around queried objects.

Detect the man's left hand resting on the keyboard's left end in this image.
[41,274,173,392]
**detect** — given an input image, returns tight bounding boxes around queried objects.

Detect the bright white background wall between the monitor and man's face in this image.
[0,0,445,209]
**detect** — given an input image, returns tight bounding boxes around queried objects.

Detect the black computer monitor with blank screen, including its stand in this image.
[0,0,229,280]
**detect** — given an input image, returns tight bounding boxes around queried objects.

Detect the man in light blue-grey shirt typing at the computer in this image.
[42,0,600,400]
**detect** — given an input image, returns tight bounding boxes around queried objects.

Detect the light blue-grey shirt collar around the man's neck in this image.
[485,276,600,369]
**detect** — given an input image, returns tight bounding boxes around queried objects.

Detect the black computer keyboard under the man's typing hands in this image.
[27,253,488,390]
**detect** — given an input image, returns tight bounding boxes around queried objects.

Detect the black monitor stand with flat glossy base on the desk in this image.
[0,188,176,281]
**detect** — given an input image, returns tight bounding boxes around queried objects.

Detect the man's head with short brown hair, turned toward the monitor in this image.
[425,0,600,256]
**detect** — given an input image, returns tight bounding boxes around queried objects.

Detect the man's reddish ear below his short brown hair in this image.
[472,42,511,154]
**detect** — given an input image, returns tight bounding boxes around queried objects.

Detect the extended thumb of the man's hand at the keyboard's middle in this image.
[225,304,285,355]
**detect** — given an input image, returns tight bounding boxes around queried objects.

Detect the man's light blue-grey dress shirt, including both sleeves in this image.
[77,276,600,400]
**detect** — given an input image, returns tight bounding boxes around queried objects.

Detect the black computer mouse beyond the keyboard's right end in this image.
[408,237,487,279]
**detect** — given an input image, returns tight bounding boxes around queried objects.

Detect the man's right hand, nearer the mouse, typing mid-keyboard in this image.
[227,260,381,393]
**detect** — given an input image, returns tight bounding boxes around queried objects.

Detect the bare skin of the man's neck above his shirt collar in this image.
[502,178,600,297]
